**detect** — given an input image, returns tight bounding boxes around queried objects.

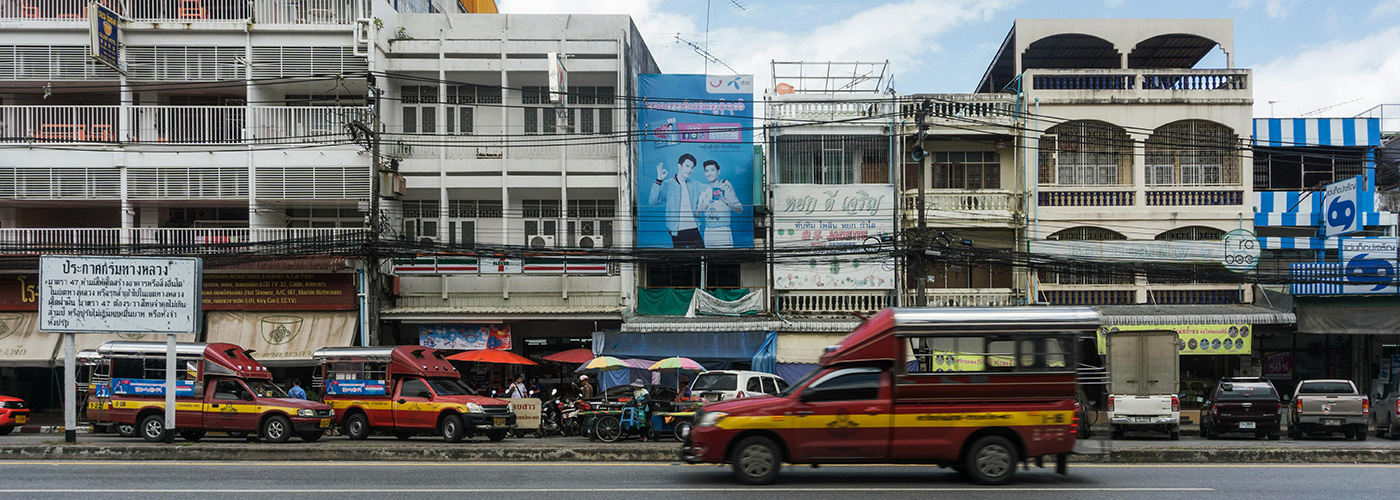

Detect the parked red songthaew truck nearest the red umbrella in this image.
[312,346,515,443]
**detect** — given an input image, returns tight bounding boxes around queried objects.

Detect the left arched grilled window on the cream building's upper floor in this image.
[1040,120,1133,186]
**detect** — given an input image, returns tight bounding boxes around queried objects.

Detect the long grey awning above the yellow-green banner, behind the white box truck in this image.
[1095,304,1298,325]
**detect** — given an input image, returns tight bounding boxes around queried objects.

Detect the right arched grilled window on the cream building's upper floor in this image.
[1144,120,1240,186]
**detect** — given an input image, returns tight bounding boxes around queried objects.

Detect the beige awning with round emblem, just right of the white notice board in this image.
[206,311,357,366]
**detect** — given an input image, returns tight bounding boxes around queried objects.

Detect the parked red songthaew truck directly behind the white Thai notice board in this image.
[100,342,333,443]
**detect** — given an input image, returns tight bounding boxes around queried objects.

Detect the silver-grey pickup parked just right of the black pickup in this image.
[1288,380,1371,441]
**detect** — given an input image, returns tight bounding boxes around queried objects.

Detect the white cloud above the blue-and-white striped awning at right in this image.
[1254,27,1400,118]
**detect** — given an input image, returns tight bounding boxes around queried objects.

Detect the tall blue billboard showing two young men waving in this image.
[636,74,753,248]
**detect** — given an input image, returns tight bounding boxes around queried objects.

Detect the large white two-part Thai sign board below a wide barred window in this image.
[773,183,897,290]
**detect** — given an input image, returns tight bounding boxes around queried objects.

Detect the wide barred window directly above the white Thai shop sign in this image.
[773,134,890,185]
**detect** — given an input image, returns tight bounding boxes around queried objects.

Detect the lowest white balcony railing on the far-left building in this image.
[0,227,367,255]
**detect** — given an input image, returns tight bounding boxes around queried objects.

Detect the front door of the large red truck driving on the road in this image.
[788,367,893,462]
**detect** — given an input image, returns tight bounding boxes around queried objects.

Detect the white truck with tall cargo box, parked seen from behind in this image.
[1105,331,1182,441]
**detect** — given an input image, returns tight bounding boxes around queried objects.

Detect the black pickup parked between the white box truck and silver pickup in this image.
[1201,378,1282,441]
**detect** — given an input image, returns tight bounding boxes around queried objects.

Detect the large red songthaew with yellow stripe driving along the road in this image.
[682,307,1099,485]
